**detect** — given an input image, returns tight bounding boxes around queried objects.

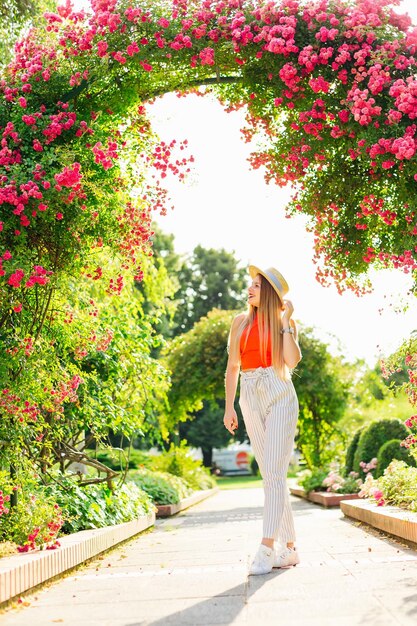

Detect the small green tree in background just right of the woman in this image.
[293,327,351,469]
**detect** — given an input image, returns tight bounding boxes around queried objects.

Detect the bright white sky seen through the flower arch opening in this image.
[74,0,417,366]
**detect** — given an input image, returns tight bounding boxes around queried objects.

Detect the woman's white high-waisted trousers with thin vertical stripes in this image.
[239,367,299,544]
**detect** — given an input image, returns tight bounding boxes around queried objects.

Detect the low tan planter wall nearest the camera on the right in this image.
[340,498,417,544]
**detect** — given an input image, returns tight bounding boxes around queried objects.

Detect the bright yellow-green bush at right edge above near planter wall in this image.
[375,460,417,513]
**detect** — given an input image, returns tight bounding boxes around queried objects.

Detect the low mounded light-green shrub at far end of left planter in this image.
[127,468,193,504]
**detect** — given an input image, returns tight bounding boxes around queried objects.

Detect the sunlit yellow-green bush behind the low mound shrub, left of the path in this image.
[152,441,216,490]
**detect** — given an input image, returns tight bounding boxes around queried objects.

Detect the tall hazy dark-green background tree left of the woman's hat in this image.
[174,245,248,334]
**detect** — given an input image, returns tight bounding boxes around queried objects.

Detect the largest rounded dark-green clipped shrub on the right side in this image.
[353,419,410,478]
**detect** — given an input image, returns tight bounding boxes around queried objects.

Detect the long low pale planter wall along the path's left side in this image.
[0,512,155,605]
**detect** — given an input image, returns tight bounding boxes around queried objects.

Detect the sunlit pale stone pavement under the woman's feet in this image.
[0,489,417,626]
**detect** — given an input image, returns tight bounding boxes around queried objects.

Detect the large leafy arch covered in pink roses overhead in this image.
[0,0,417,478]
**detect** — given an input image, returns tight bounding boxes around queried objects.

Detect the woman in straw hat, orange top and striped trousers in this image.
[223,265,302,575]
